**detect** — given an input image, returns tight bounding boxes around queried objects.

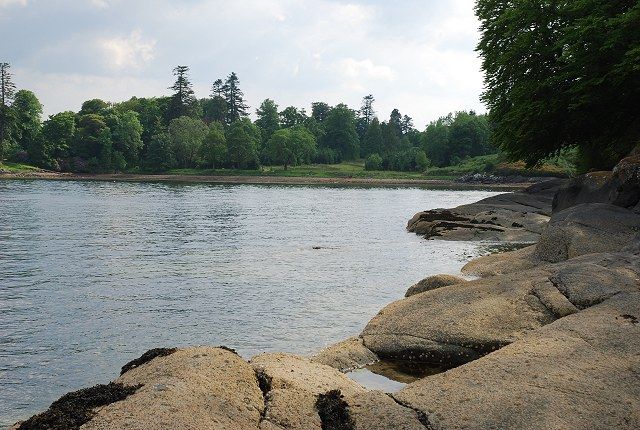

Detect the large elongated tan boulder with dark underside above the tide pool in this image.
[361,253,640,367]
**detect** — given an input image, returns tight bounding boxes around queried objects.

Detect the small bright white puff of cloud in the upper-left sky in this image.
[99,30,156,70]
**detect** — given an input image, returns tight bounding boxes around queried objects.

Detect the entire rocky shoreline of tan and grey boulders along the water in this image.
[13,155,640,430]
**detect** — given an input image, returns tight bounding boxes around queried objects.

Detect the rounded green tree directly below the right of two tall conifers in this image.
[226,118,261,169]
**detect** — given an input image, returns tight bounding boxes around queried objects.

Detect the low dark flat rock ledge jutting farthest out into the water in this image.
[407,180,562,242]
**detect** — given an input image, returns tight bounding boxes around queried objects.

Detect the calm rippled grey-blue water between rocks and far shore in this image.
[0,181,495,425]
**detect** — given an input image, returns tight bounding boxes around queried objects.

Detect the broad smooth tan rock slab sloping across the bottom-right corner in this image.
[394,293,640,430]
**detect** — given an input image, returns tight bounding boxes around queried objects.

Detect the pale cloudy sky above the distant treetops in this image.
[0,0,485,129]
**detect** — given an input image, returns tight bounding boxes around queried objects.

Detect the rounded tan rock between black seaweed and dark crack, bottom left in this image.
[81,347,264,430]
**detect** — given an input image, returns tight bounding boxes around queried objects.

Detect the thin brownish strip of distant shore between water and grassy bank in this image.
[0,171,531,190]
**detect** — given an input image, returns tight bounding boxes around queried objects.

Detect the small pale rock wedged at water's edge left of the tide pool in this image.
[311,337,379,373]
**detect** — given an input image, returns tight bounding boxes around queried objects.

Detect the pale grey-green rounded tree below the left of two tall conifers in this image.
[169,116,209,167]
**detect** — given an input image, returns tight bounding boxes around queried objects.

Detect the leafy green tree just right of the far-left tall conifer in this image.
[12,90,45,164]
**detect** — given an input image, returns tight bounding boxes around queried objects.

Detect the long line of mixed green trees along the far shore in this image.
[0,63,495,172]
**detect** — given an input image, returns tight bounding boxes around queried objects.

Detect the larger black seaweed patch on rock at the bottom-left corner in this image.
[18,382,140,430]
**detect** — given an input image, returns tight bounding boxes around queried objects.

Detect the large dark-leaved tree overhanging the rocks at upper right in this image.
[475,0,640,168]
